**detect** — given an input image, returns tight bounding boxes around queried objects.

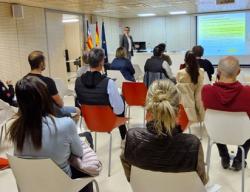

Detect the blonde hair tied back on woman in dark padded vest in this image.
[146,80,180,135]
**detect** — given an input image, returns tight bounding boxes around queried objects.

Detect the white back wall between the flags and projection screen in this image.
[121,15,196,51]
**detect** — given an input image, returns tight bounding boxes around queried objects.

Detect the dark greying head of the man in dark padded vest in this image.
[88,48,105,68]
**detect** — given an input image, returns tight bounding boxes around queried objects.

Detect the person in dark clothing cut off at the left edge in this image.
[0,80,17,107]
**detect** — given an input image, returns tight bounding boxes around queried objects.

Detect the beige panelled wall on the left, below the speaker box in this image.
[0,3,70,83]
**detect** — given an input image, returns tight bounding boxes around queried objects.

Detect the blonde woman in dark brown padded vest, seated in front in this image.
[121,80,207,184]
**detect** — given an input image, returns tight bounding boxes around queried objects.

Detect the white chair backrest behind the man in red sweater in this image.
[204,109,250,145]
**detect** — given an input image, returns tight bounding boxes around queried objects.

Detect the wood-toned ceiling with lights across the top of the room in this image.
[2,0,250,18]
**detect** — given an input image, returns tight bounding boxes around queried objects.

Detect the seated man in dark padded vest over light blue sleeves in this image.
[75,48,127,140]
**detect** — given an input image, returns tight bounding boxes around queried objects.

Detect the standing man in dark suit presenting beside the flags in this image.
[120,27,134,60]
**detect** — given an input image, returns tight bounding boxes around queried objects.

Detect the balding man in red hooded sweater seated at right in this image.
[201,56,250,171]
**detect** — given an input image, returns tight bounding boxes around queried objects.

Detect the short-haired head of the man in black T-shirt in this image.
[28,51,45,70]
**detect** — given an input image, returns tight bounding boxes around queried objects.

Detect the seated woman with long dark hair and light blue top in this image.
[7,76,93,192]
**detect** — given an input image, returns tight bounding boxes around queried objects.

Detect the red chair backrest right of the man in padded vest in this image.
[122,82,147,106]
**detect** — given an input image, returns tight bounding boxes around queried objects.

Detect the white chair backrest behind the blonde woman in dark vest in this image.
[130,166,206,192]
